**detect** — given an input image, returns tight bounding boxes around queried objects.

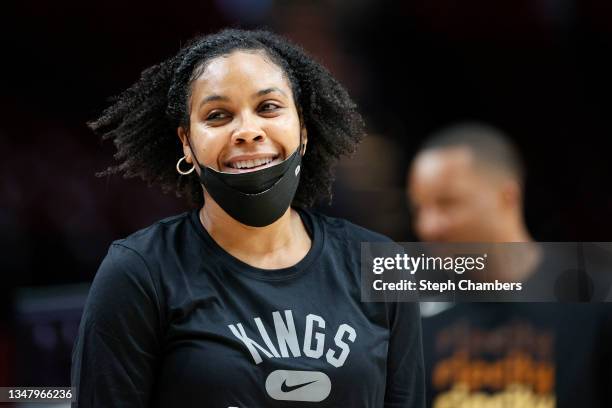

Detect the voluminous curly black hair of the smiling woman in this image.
[88,29,365,207]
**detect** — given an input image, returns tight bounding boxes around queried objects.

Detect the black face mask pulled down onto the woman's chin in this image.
[186,139,302,227]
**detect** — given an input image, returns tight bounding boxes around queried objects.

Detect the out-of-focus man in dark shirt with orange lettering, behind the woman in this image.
[407,123,612,408]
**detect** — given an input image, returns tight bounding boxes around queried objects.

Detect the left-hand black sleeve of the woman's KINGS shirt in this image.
[71,243,161,408]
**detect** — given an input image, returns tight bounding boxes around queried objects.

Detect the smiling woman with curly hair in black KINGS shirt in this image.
[72,30,424,407]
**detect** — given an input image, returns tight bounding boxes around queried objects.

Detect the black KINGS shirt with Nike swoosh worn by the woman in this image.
[72,210,424,408]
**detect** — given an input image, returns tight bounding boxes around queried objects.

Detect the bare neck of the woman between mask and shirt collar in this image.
[199,195,311,269]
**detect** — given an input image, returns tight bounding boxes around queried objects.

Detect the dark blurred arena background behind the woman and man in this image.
[0,0,612,402]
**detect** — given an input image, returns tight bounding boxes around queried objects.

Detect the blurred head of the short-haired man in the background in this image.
[408,124,531,242]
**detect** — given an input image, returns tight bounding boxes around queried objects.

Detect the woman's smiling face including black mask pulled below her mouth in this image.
[178,50,308,227]
